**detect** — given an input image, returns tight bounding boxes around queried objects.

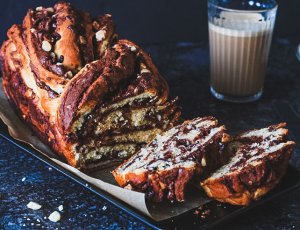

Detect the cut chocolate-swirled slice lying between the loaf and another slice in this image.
[112,117,226,202]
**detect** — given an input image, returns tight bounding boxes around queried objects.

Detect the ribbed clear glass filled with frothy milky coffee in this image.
[208,0,277,102]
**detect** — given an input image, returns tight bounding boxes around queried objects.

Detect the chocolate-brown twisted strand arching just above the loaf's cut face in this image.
[58,44,135,130]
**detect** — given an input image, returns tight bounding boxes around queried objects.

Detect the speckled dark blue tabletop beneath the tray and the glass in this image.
[0,39,300,229]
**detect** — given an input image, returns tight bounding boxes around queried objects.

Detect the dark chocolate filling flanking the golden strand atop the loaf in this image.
[31,4,94,77]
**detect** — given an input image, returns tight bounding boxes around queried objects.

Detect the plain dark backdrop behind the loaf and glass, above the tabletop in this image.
[0,0,300,44]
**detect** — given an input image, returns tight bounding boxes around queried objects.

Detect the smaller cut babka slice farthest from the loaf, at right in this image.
[201,123,295,205]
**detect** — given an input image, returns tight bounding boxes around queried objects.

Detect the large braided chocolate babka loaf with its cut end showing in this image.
[0,2,180,169]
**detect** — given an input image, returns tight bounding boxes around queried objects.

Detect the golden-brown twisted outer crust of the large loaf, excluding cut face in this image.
[0,2,180,170]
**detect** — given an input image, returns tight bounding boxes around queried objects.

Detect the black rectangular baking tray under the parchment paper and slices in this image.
[0,119,300,229]
